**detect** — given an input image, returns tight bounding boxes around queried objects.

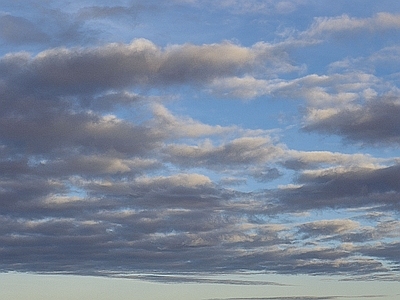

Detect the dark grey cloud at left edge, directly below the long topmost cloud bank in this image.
[0,111,159,154]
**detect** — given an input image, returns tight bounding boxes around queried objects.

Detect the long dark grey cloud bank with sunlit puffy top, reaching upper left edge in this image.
[0,39,268,94]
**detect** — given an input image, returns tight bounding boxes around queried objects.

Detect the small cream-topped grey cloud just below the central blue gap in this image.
[163,135,286,183]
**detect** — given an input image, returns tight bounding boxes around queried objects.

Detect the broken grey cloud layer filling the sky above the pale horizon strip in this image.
[0,1,400,282]
